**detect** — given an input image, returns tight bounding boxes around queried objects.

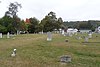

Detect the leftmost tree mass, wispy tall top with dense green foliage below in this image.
[0,2,22,33]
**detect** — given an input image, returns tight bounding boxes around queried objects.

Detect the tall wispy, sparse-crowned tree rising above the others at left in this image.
[5,2,22,30]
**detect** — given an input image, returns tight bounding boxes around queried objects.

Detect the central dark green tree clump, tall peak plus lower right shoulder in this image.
[40,11,64,32]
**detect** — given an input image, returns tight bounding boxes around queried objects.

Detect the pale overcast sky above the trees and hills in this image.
[0,0,100,21]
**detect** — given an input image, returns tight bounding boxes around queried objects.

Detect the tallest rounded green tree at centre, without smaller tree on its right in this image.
[41,11,57,32]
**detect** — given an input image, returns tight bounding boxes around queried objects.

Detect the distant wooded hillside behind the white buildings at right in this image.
[64,20,100,31]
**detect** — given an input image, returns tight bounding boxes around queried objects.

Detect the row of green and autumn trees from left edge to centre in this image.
[0,2,63,33]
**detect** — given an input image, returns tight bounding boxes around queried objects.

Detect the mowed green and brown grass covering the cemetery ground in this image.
[0,34,100,67]
